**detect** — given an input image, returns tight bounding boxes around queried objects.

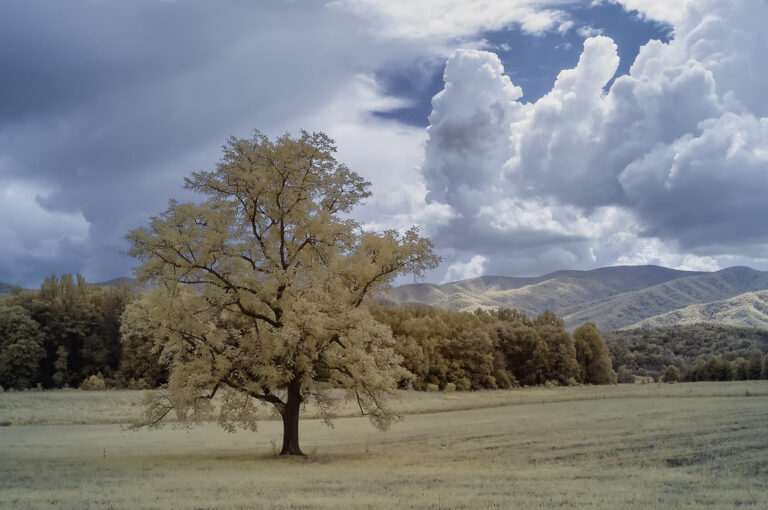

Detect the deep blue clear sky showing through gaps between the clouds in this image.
[373,2,672,127]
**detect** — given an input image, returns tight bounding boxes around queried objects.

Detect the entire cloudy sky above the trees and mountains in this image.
[0,0,768,288]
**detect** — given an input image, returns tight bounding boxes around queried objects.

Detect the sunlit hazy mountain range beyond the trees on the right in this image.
[380,266,768,330]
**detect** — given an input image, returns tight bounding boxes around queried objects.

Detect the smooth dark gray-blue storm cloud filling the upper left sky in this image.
[0,0,426,285]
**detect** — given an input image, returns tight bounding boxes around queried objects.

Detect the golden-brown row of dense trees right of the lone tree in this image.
[373,304,616,390]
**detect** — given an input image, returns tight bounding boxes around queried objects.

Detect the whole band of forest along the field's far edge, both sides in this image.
[0,275,768,391]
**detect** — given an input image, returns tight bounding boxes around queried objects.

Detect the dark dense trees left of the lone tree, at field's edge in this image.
[0,274,168,389]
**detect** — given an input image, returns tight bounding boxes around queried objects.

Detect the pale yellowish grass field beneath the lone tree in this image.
[0,381,768,508]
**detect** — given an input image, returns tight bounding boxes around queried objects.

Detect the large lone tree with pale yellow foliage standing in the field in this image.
[123,132,439,455]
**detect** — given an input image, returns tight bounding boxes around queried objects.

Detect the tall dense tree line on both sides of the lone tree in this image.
[0,274,616,391]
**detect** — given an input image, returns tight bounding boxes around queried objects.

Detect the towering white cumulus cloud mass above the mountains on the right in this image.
[422,0,768,278]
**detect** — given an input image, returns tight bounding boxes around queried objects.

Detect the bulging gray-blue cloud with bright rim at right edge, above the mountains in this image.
[619,113,768,252]
